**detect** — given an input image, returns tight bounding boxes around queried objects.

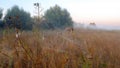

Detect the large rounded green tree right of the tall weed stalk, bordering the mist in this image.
[44,5,73,29]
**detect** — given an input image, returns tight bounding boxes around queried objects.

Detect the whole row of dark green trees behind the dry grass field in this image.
[0,5,73,30]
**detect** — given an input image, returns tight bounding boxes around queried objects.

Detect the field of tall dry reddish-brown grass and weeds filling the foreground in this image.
[0,30,120,68]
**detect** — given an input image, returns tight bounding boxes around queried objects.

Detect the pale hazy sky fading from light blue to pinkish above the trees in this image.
[0,0,120,27]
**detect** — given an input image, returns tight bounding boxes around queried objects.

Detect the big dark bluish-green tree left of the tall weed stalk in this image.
[4,5,32,30]
